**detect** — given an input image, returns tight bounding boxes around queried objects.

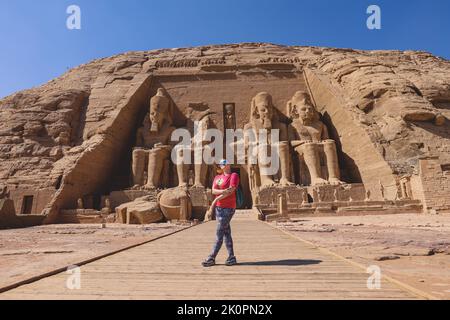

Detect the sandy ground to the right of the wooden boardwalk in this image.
[274,214,450,299]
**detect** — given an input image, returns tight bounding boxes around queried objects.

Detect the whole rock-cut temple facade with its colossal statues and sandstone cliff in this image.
[0,43,450,228]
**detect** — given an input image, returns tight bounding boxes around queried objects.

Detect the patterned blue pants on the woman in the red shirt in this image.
[210,207,236,259]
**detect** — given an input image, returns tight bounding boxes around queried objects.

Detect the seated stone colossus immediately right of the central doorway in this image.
[244,92,293,187]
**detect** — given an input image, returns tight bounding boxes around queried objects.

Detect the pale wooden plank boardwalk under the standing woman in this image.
[0,214,418,300]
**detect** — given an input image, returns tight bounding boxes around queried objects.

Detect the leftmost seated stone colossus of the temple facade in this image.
[132,89,175,189]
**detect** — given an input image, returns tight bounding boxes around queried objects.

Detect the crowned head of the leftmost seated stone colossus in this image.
[149,88,172,132]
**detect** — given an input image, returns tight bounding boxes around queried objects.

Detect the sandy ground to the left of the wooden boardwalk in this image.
[0,223,186,288]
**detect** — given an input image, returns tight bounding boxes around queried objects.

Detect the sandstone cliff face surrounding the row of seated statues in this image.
[0,43,450,222]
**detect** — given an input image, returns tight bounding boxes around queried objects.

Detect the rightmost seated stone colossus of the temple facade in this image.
[287,91,342,185]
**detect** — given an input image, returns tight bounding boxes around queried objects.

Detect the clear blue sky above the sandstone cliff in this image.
[0,0,450,97]
